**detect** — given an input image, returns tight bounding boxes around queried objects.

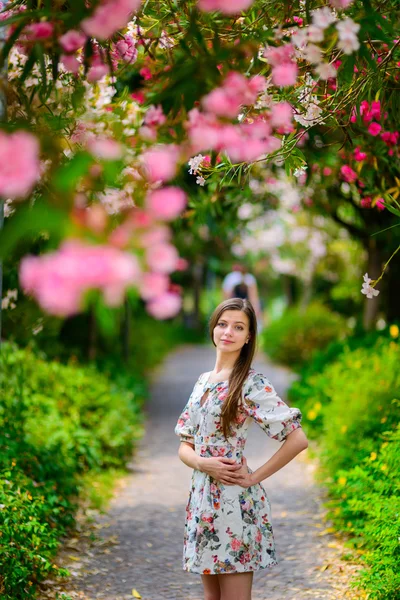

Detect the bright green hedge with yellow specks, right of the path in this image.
[289,336,400,600]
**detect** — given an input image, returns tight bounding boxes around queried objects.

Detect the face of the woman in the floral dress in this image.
[213,310,250,352]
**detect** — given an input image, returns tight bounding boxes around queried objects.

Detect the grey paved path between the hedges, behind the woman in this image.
[54,346,362,600]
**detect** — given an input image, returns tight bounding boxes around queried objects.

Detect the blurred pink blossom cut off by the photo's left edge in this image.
[0,131,40,199]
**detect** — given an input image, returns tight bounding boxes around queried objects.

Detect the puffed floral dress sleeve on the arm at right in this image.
[243,373,302,442]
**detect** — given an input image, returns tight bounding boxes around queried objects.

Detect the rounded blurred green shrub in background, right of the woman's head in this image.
[261,303,348,369]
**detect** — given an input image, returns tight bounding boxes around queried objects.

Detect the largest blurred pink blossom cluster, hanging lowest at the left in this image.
[20,240,140,316]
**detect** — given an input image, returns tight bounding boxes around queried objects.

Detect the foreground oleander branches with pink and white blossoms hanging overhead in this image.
[0,0,400,330]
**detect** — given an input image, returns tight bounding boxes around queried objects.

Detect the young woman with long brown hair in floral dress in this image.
[175,298,308,600]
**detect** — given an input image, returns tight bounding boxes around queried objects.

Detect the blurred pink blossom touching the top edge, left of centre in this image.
[81,0,140,40]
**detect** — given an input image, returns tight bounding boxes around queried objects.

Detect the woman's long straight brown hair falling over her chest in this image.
[210,298,257,438]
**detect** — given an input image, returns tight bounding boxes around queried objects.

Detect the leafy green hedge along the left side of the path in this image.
[0,345,143,600]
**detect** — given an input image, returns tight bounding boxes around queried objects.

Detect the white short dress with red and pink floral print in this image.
[175,369,302,575]
